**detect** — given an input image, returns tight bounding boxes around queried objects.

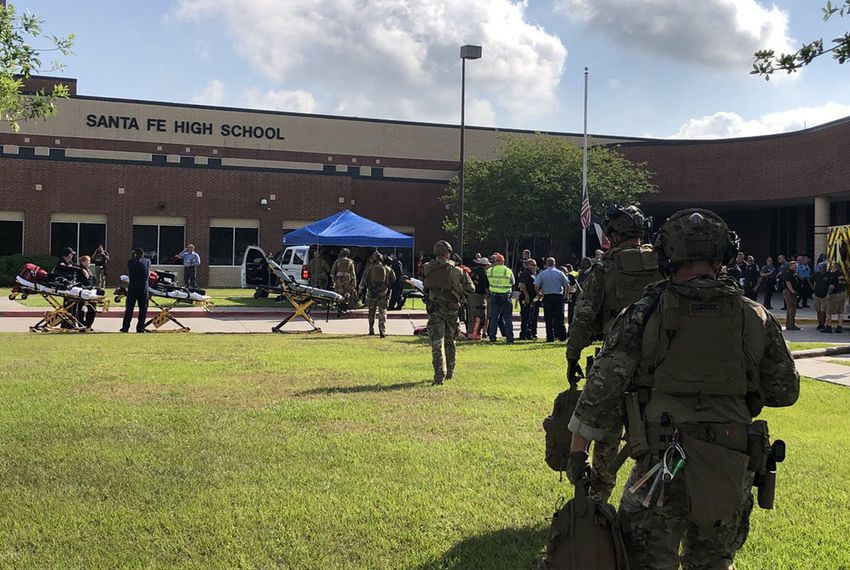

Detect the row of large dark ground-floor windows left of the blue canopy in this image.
[0,220,260,265]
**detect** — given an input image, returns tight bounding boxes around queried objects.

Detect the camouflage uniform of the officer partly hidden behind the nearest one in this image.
[567,240,661,499]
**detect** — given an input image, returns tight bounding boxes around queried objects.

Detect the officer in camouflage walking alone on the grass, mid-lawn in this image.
[424,240,475,385]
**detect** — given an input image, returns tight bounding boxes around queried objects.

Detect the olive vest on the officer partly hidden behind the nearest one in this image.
[599,244,661,336]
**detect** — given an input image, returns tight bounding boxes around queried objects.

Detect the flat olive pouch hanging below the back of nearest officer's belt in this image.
[682,434,749,532]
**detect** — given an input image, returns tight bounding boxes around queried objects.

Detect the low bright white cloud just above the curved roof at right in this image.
[668,101,850,139]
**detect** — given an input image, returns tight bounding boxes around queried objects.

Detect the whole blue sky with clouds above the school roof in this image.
[13,0,850,138]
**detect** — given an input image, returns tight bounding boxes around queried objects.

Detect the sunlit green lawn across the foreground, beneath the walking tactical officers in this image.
[0,334,850,570]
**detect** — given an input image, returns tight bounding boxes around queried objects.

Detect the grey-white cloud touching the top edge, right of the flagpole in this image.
[557,0,796,67]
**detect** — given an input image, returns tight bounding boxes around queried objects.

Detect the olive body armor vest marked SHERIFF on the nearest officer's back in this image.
[638,288,758,398]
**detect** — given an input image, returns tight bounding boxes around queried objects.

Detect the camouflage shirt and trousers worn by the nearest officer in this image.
[569,211,800,568]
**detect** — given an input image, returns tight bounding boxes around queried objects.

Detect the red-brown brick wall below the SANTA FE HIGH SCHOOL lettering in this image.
[0,156,445,283]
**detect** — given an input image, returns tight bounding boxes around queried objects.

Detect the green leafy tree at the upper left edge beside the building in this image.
[0,2,74,132]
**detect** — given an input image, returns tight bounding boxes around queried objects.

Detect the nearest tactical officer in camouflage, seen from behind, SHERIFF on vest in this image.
[567,210,800,568]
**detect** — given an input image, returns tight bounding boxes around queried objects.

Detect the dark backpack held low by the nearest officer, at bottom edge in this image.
[540,479,629,570]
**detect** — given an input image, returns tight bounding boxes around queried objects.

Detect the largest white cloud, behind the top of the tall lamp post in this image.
[169,0,567,125]
